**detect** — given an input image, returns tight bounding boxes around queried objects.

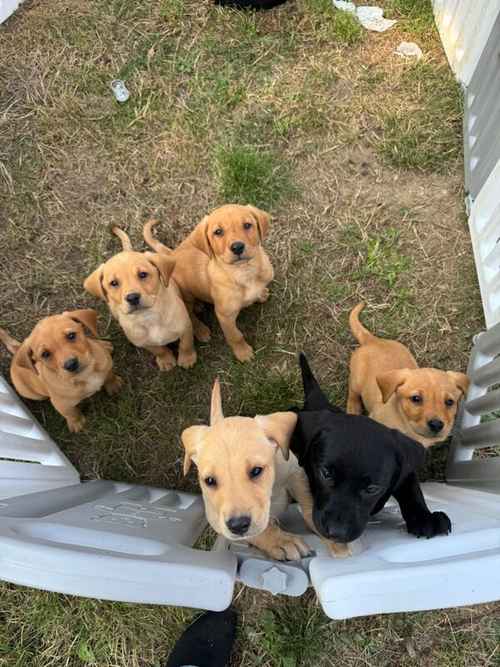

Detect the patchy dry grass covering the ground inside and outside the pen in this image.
[0,0,492,667]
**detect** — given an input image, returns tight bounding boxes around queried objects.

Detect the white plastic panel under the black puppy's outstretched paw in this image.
[310,484,500,619]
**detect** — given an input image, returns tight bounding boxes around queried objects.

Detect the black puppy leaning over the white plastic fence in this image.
[291,354,451,542]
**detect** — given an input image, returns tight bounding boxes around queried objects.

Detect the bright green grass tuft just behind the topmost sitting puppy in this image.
[215,145,293,208]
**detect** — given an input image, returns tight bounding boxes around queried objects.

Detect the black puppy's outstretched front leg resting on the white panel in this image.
[394,473,451,539]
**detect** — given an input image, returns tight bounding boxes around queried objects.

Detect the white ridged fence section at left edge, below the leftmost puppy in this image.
[0,376,80,499]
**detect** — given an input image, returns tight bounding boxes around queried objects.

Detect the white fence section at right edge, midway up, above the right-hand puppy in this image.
[469,162,500,328]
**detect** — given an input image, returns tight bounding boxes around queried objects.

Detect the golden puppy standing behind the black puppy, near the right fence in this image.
[347,303,469,447]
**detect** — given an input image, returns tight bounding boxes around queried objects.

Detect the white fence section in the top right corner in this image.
[432,0,500,85]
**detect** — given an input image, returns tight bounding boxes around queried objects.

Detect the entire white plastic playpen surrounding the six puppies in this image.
[0,0,500,618]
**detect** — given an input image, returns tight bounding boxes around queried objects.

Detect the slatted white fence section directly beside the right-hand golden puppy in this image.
[446,324,500,493]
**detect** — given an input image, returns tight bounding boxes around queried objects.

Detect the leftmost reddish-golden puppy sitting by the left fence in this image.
[0,310,122,432]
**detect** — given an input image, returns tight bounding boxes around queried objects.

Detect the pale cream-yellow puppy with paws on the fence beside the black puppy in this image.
[181,380,349,560]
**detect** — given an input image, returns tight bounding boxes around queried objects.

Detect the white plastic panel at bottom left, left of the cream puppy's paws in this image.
[0,481,237,611]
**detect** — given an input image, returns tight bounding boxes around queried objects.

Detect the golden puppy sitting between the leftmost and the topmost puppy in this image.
[83,227,196,371]
